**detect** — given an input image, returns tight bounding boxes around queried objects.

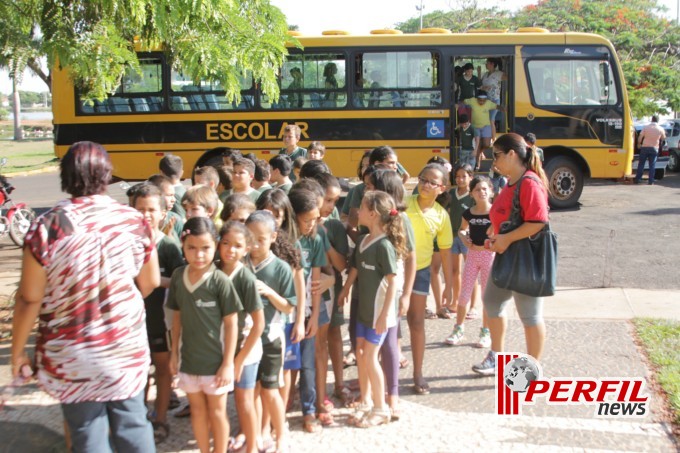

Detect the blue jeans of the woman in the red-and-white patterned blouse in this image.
[61,390,156,453]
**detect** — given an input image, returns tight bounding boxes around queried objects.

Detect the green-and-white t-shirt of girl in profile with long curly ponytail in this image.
[351,234,397,328]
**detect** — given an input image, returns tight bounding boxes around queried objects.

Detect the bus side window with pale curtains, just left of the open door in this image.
[353,51,442,108]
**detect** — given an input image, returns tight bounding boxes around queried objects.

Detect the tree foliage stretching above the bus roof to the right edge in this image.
[397,0,680,117]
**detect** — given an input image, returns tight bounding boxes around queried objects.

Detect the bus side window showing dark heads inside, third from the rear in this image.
[262,54,347,109]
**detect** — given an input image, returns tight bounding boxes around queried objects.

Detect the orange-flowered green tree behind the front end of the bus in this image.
[513,0,680,117]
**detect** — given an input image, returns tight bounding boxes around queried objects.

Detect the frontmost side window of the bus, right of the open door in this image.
[527,59,618,106]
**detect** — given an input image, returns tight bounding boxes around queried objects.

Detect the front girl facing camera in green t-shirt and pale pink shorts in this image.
[167,217,243,452]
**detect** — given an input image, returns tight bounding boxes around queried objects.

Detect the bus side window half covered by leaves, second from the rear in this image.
[170,69,254,112]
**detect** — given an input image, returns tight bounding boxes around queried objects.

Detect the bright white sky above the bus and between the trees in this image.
[0,0,678,94]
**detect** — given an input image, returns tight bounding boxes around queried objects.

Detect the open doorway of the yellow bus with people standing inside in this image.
[450,48,514,166]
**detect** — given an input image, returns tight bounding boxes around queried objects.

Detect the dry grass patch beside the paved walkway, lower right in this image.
[633,318,680,427]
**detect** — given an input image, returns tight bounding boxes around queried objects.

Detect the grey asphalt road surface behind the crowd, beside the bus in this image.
[0,173,680,289]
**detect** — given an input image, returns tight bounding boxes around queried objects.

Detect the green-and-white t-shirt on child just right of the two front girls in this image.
[246,252,297,345]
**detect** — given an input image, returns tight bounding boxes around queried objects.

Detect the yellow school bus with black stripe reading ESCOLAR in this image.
[52,28,633,207]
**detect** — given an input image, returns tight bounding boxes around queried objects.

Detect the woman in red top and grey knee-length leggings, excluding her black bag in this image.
[472,133,548,375]
